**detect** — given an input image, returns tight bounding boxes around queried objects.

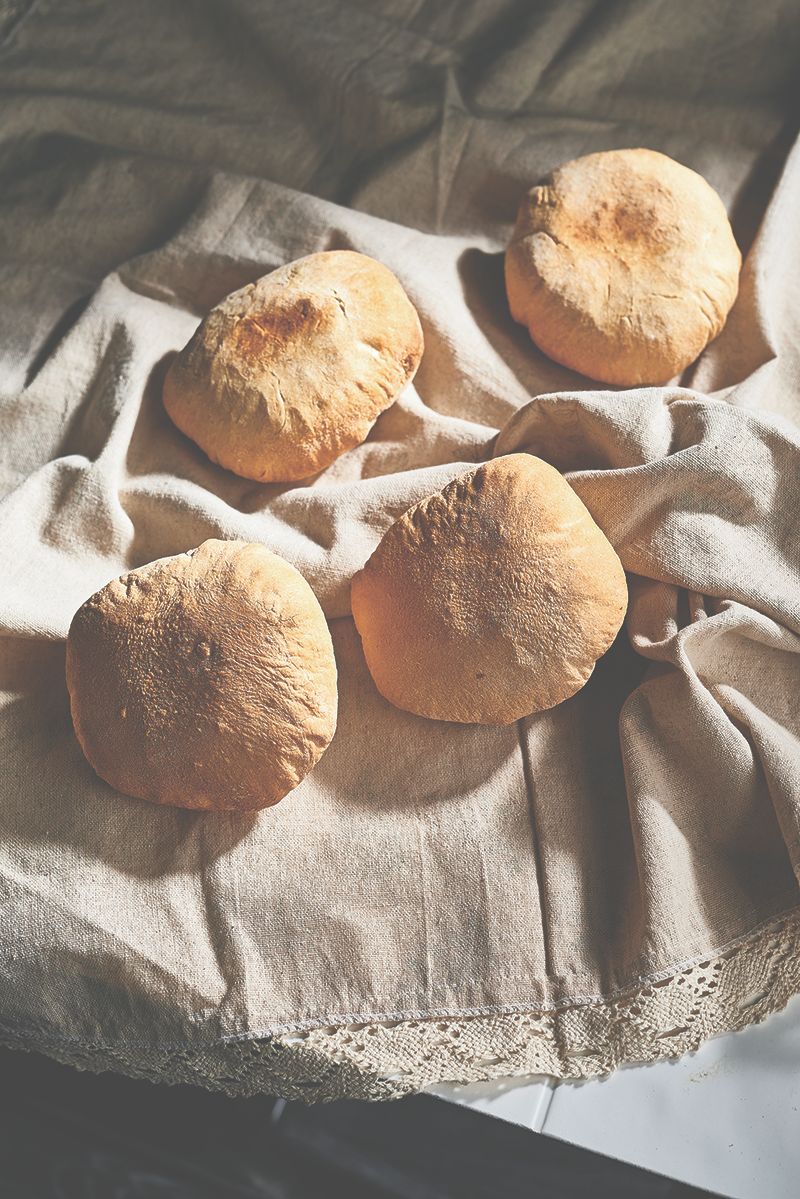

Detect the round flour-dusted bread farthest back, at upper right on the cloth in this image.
[505,150,741,387]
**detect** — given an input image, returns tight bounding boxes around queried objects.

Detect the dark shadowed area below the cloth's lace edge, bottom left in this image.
[0,1050,706,1199]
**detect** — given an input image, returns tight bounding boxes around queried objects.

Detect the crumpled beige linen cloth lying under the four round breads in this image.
[0,4,800,1096]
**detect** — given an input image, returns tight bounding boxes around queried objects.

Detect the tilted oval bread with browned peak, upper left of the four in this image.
[164,249,422,482]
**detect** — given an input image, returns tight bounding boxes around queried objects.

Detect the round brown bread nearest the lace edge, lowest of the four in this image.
[67,541,337,812]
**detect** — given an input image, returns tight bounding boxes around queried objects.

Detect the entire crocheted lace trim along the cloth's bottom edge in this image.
[0,911,800,1102]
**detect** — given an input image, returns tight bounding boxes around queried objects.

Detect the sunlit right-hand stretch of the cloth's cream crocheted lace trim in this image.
[282,912,800,1091]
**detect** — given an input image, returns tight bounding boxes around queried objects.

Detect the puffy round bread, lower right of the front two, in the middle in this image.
[351,453,627,724]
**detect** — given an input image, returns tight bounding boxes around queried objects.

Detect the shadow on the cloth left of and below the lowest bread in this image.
[0,638,257,878]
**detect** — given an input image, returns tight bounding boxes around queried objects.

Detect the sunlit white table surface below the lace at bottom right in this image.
[432,996,800,1199]
